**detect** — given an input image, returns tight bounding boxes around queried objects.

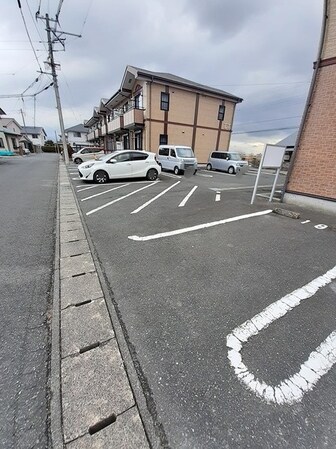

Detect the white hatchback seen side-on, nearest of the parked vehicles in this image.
[78,150,161,183]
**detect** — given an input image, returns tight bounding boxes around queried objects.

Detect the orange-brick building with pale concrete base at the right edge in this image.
[284,0,336,211]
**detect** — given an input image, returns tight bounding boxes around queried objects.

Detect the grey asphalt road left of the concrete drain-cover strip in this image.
[0,155,58,449]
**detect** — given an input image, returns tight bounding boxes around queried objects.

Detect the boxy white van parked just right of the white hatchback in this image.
[156,145,197,175]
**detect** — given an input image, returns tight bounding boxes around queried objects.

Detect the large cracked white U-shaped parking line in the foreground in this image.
[226,266,336,404]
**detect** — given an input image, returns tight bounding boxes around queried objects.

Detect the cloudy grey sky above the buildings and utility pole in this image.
[0,0,323,153]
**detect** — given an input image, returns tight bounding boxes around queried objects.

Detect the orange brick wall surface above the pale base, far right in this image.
[286,0,336,200]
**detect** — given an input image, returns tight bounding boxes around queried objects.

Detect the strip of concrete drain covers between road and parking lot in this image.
[51,161,150,449]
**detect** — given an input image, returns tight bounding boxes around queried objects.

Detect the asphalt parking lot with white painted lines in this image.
[69,165,336,448]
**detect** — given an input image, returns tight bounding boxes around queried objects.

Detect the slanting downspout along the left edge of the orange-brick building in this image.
[281,0,329,202]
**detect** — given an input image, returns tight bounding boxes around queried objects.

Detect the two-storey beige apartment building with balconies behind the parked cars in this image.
[85,66,242,163]
